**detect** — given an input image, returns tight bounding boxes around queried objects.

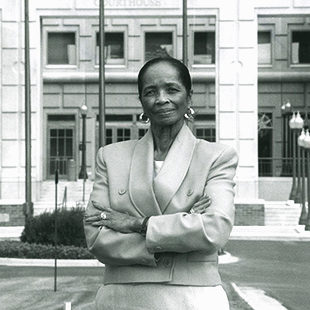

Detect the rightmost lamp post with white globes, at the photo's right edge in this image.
[298,129,309,225]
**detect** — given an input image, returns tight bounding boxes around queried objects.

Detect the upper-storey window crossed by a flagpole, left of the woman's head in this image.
[96,32,125,65]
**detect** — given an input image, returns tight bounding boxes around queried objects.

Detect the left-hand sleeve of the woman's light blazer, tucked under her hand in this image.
[84,148,156,266]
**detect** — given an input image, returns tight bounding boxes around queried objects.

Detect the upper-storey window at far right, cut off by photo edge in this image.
[291,31,310,64]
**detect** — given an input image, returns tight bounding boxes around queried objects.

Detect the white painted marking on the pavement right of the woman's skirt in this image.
[231,282,287,310]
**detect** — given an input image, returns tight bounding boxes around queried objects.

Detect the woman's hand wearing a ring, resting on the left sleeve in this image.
[85,201,143,233]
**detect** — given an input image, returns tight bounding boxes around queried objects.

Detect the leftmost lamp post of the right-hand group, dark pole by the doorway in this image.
[281,101,292,176]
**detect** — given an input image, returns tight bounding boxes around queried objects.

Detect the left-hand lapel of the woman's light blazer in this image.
[129,129,162,216]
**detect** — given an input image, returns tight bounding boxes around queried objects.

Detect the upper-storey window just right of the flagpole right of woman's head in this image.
[194,31,215,65]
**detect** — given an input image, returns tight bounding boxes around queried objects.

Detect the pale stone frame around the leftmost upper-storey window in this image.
[42,25,80,70]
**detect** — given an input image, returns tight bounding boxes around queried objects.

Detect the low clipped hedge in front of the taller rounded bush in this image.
[0,241,94,259]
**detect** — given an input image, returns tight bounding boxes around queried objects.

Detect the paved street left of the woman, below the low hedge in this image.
[0,266,103,310]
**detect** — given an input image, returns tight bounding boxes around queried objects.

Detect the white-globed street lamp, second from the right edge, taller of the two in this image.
[289,111,304,202]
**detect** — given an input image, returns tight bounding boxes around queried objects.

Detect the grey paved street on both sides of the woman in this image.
[0,239,310,310]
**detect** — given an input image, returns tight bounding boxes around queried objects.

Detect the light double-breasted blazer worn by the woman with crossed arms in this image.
[85,125,237,286]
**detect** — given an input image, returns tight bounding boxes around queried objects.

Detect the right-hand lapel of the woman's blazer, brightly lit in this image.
[152,124,197,212]
